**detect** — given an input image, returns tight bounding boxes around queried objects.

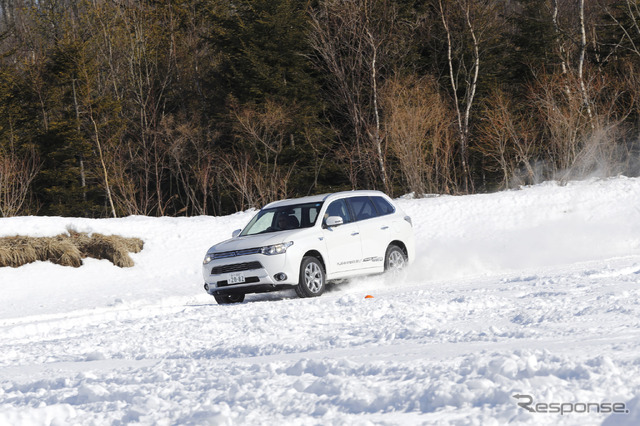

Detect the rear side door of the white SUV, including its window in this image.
[349,196,391,269]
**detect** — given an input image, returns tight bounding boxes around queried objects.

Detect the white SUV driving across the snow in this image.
[202,191,415,304]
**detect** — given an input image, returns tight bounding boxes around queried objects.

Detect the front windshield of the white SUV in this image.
[240,202,322,236]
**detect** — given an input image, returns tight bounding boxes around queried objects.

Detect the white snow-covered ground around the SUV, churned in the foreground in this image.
[0,177,640,425]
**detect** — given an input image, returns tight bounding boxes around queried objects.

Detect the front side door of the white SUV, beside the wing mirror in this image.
[322,199,362,275]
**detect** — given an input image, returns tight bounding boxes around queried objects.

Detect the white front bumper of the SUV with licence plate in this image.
[202,253,298,295]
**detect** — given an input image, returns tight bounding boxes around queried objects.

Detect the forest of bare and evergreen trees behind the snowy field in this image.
[0,0,640,217]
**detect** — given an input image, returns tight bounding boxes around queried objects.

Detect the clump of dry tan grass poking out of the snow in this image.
[0,231,144,268]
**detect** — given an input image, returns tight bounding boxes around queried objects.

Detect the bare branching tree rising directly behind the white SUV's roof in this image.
[310,0,397,190]
